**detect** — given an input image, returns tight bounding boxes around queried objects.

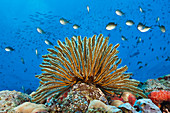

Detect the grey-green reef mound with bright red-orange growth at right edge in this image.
[141,74,170,112]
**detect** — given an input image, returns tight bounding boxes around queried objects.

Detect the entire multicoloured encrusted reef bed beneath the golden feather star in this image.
[0,75,170,113]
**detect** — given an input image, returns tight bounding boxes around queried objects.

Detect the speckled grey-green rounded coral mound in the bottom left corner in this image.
[0,90,30,112]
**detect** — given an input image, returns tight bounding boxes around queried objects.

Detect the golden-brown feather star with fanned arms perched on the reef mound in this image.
[32,34,146,102]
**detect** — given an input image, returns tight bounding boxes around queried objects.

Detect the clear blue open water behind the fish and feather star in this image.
[0,0,170,91]
